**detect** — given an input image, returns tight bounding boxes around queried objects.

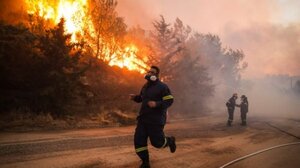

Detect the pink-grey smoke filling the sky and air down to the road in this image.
[117,0,300,118]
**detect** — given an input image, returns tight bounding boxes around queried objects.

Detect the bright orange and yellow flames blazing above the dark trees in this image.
[25,0,148,73]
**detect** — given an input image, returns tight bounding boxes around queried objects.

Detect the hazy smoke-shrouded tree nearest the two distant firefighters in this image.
[188,33,248,95]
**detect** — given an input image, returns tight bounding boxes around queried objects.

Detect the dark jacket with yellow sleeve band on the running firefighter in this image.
[134,80,174,125]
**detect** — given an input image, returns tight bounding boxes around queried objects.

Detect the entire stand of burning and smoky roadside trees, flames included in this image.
[0,0,244,126]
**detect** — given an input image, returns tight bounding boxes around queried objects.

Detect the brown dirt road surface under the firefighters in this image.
[0,114,300,168]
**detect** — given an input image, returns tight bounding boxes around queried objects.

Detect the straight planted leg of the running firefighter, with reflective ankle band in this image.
[134,122,149,164]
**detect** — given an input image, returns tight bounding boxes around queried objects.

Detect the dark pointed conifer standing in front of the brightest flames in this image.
[38,19,88,116]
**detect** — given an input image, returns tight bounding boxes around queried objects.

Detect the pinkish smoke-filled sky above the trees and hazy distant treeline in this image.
[117,0,300,78]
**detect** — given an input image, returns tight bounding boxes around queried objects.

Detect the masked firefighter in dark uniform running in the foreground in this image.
[130,66,176,168]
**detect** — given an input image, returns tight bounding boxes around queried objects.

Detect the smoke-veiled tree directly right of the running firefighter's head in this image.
[151,16,213,114]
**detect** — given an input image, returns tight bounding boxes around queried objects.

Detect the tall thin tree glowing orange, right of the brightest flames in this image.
[89,0,126,61]
